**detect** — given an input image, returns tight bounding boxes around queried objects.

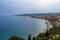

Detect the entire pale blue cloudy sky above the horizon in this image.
[0,0,60,15]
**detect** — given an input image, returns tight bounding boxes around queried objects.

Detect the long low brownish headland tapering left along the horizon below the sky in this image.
[17,13,60,19]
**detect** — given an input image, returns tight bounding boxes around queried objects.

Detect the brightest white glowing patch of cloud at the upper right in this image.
[36,0,60,6]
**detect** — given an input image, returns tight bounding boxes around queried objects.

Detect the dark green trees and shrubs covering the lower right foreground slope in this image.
[36,26,60,40]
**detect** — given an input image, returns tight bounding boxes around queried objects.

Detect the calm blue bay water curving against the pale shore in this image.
[0,16,46,40]
